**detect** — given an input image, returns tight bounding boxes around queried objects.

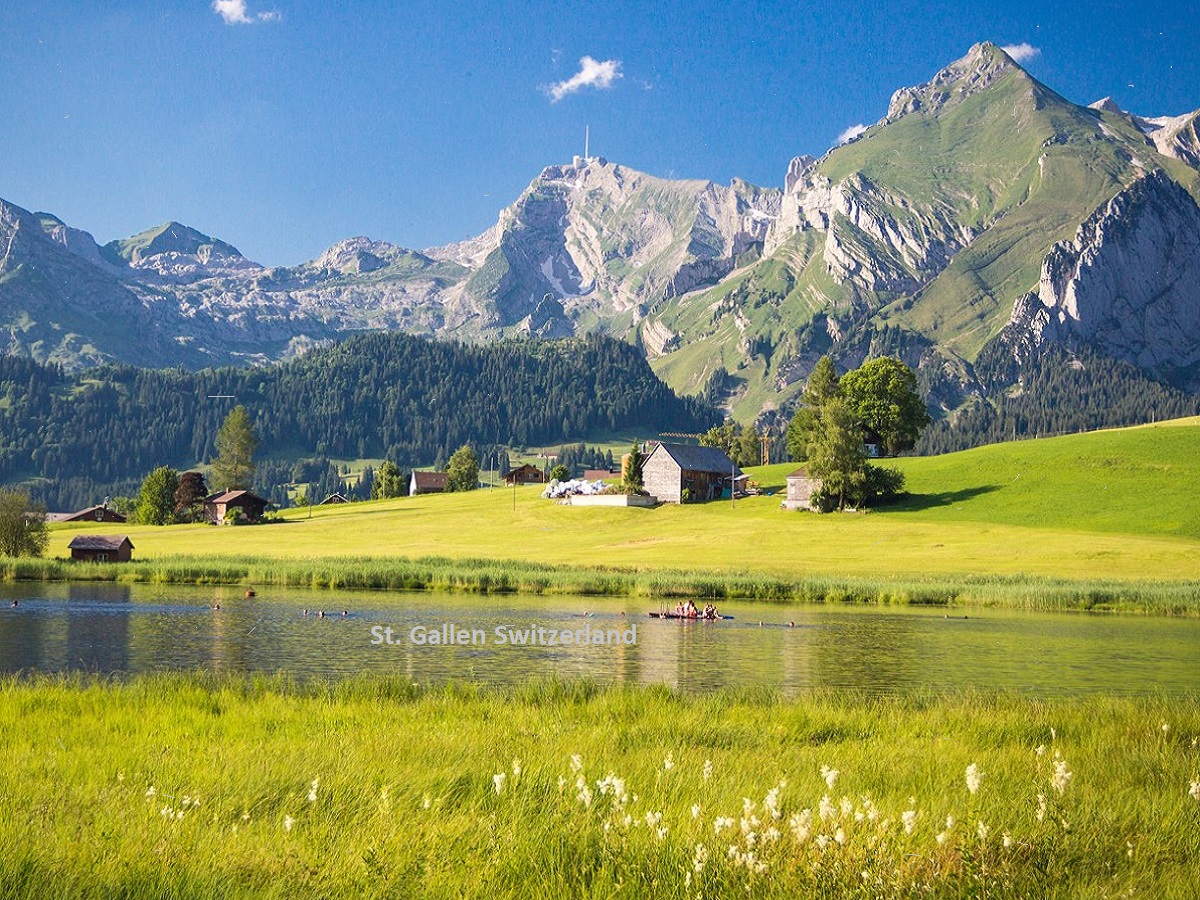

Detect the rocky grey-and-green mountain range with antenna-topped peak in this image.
[0,43,1200,421]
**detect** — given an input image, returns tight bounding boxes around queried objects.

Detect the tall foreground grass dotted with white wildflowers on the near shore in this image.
[0,676,1200,900]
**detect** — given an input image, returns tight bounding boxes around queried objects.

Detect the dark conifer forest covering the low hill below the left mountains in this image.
[0,332,719,509]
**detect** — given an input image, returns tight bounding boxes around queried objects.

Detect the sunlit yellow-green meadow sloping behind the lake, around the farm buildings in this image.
[16,419,1200,606]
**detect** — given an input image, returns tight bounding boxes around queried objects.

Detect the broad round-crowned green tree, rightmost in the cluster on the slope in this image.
[839,356,930,456]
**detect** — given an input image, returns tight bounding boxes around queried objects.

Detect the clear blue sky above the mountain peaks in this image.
[0,0,1200,265]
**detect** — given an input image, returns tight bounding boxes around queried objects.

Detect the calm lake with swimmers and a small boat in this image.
[0,583,1200,696]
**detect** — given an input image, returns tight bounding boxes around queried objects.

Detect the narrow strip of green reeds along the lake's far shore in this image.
[7,557,1200,617]
